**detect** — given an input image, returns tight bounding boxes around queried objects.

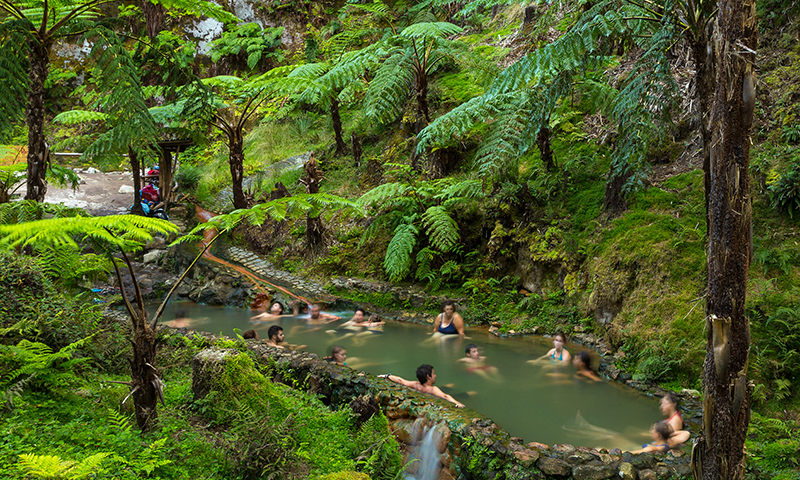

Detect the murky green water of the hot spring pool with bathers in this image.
[153,302,661,450]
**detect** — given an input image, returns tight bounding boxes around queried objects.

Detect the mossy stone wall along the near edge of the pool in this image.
[193,340,691,480]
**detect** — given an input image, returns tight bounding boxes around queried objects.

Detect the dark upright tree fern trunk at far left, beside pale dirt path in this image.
[25,40,50,202]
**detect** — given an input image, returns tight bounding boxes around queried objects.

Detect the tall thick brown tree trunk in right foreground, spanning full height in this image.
[693,0,757,480]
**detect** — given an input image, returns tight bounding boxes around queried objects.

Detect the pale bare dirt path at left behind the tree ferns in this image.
[45,168,133,216]
